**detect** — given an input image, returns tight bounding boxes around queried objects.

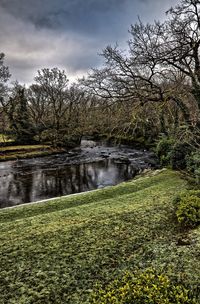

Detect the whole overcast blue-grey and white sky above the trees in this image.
[0,0,178,84]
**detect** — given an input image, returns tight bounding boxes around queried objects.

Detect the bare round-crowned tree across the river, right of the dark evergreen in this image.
[32,68,83,145]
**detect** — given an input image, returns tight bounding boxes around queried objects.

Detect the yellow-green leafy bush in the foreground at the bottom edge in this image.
[90,269,197,304]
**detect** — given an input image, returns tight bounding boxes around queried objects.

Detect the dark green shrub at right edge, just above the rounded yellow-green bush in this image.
[187,151,200,184]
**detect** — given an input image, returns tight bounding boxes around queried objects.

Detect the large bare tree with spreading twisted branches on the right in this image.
[83,0,200,134]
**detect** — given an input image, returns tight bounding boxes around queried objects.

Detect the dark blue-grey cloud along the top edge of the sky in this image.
[1,0,130,35]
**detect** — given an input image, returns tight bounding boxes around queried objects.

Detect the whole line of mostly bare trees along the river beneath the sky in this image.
[0,0,200,151]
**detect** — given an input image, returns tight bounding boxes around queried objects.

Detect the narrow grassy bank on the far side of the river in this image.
[0,145,64,161]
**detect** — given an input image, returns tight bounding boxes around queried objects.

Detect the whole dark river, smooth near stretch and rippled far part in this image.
[0,141,158,208]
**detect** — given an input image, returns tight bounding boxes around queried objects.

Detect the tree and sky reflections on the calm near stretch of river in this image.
[0,159,136,208]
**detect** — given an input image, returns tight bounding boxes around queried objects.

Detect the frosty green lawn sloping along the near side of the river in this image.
[0,170,200,304]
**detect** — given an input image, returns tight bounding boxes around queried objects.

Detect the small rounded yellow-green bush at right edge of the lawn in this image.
[176,190,200,228]
